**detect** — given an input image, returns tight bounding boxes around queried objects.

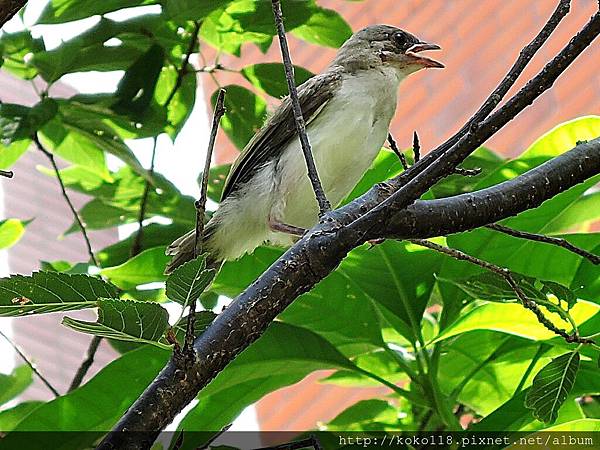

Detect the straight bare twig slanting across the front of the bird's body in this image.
[272,0,331,216]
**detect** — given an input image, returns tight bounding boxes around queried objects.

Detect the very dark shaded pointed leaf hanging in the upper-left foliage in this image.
[113,44,165,119]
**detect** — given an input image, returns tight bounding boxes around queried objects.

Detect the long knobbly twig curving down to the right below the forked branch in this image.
[410,239,594,344]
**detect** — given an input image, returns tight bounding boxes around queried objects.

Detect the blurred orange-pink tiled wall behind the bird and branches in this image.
[203,0,600,430]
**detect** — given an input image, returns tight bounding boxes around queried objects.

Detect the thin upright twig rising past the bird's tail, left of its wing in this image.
[181,88,225,357]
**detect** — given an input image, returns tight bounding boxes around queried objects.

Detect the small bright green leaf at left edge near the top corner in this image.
[0,30,45,80]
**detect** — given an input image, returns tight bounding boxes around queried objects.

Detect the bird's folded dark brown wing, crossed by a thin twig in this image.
[221,70,342,201]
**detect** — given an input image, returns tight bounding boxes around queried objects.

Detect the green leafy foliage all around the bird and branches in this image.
[0,0,600,448]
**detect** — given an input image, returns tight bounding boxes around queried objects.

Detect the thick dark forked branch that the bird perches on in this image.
[100,4,600,449]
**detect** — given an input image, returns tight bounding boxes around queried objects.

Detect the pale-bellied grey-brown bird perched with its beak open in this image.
[165,24,444,274]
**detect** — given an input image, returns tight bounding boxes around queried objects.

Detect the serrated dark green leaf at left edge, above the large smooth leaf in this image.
[0,272,117,317]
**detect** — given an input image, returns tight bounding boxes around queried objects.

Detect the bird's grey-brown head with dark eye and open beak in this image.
[333,25,444,76]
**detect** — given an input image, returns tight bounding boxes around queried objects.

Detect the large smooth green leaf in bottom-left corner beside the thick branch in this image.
[2,346,170,449]
